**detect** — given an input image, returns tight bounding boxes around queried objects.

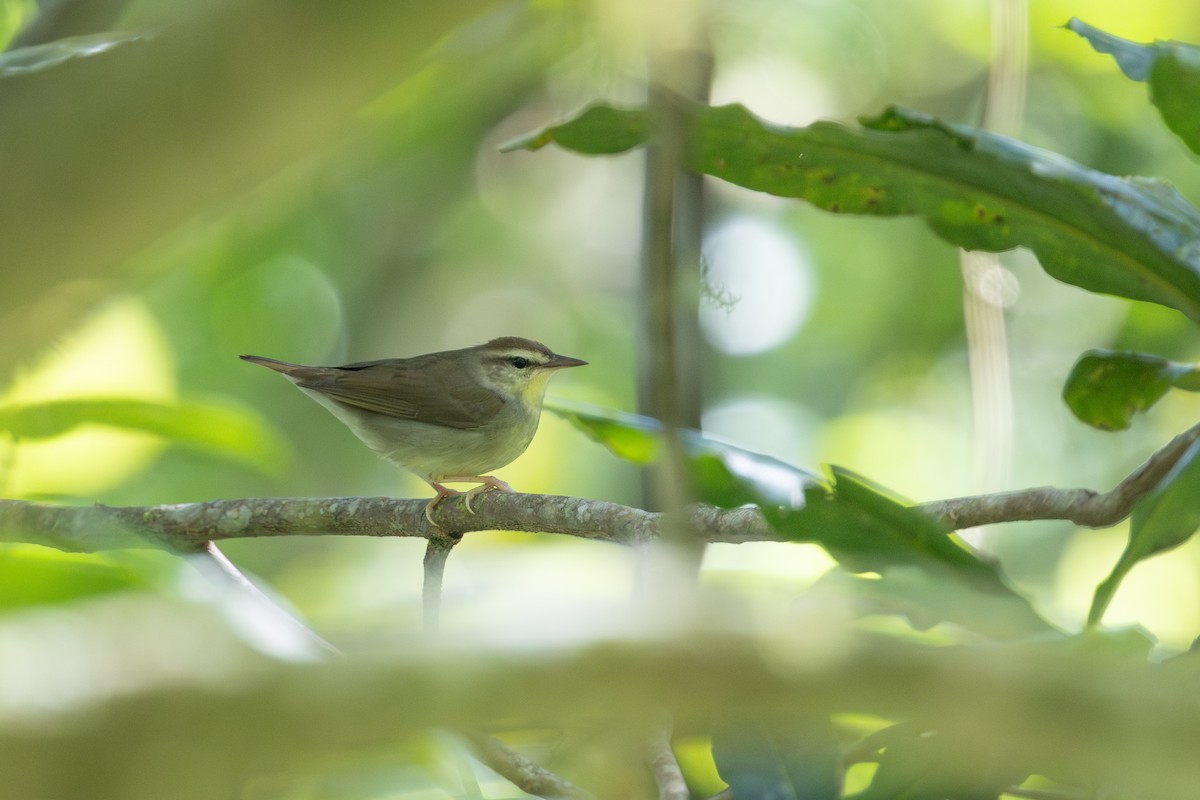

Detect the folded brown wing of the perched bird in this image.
[290,356,504,429]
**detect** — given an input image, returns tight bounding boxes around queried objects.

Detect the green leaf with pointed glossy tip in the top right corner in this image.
[1067,18,1200,154]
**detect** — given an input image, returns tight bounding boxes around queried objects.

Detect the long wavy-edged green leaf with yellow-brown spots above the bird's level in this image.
[524,106,1200,320]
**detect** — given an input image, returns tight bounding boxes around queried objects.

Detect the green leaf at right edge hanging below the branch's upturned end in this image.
[1087,440,1200,627]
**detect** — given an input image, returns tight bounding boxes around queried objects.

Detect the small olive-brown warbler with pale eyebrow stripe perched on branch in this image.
[240,336,587,527]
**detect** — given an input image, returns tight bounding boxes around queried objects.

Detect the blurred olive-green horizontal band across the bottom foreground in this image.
[0,606,1200,800]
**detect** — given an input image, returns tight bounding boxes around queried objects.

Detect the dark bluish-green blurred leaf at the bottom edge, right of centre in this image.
[713,716,841,800]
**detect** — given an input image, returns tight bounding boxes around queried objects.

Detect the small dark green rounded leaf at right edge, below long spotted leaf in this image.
[1062,350,1200,431]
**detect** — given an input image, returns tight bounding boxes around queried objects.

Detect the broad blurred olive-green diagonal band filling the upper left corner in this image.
[0,0,492,368]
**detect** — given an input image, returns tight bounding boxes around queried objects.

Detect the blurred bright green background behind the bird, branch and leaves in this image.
[0,0,1200,786]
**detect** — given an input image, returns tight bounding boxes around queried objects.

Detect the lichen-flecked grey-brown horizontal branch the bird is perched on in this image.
[0,425,1200,553]
